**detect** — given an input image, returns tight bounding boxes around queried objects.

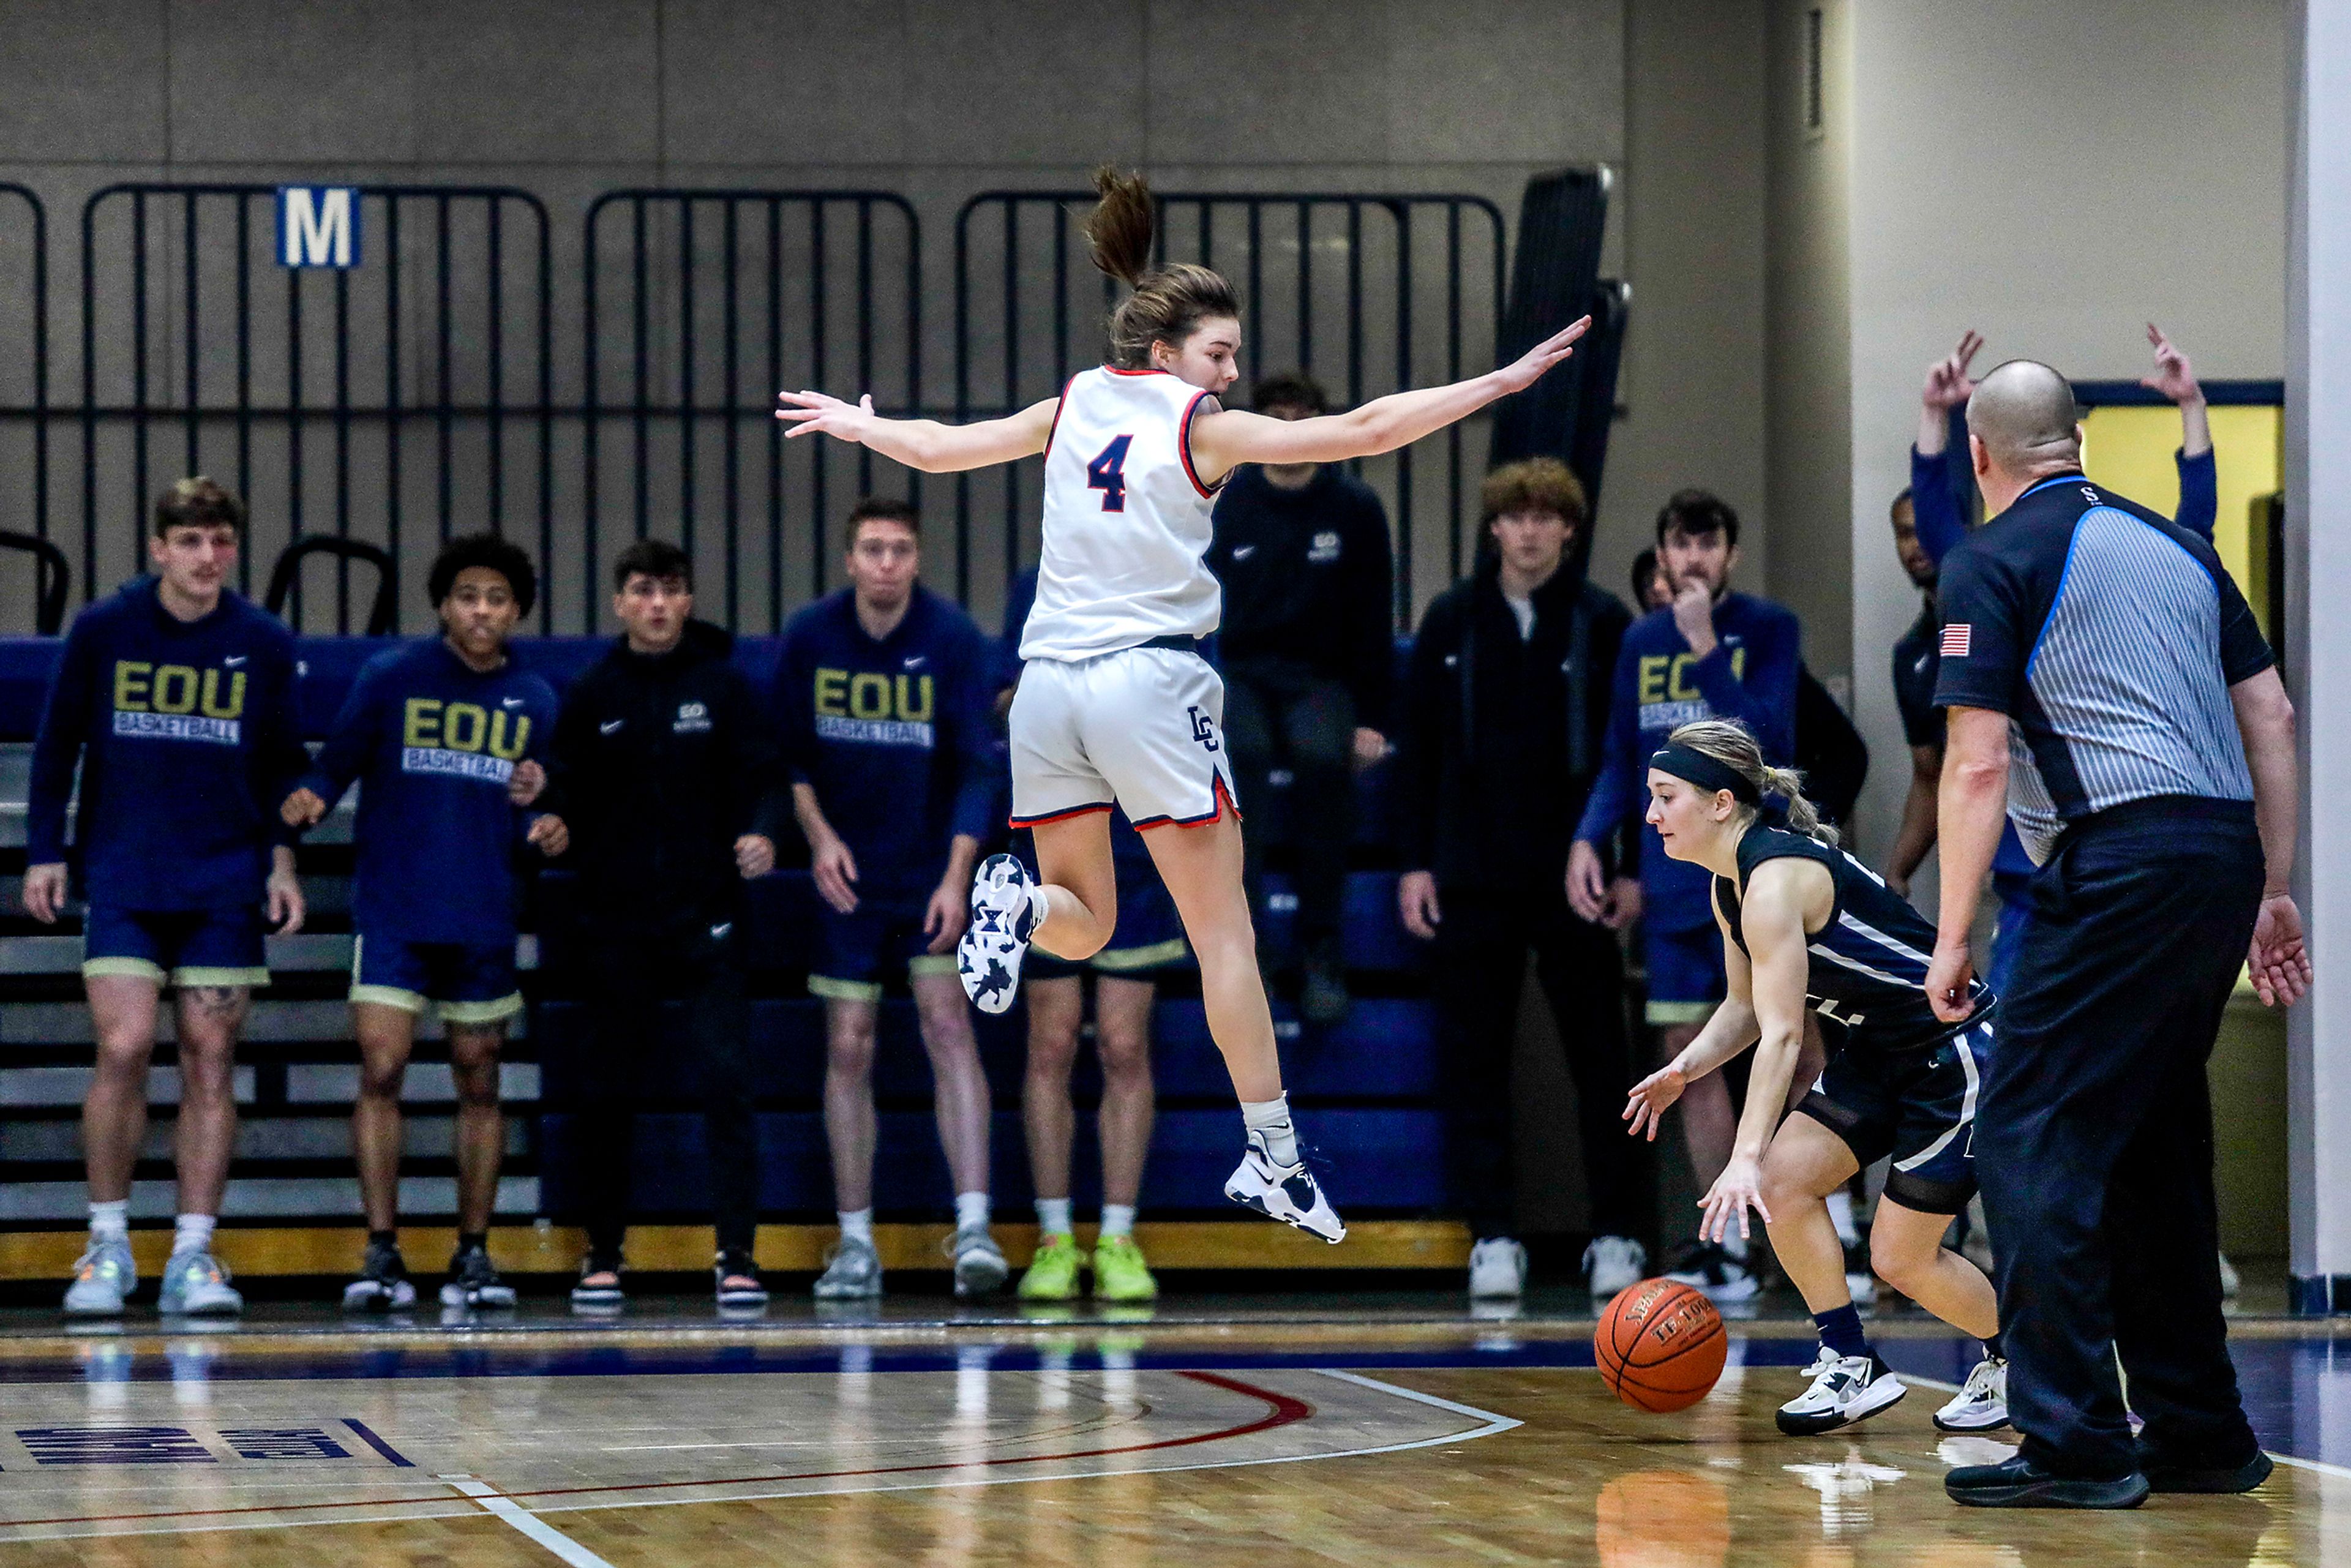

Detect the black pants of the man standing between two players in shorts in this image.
[574,917,759,1258]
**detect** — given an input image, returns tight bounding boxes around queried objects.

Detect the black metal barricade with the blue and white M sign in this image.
[80,183,557,632]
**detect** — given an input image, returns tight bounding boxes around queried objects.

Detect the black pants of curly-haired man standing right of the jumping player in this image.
[1436,887,1638,1241]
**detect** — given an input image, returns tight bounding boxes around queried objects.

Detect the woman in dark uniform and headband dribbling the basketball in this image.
[1624,719,2008,1436]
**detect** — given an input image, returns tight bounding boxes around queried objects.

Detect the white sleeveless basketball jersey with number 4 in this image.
[1021,364,1223,661]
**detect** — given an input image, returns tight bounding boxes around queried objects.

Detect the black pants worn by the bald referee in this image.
[1975,797,2262,1479]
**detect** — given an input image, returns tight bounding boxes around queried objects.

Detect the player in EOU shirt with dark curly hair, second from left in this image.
[285,534,562,1310]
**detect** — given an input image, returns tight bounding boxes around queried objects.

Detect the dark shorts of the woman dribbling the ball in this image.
[1796,1020,1991,1213]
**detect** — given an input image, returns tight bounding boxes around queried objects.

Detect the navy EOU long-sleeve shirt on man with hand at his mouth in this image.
[1575,593,1801,931]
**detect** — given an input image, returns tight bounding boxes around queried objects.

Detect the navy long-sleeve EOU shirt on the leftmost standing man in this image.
[26,576,308,910]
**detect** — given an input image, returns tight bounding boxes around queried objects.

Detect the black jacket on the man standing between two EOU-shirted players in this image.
[548,621,790,926]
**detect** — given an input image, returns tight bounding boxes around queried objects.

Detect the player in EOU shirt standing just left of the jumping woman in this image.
[776,498,1007,1300]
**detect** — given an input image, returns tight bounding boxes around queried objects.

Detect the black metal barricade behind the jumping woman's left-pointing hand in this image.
[580,190,921,630]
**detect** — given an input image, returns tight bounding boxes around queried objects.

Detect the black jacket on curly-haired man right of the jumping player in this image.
[1399,550,1632,888]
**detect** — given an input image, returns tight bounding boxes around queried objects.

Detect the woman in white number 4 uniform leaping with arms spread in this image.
[776,167,1589,1241]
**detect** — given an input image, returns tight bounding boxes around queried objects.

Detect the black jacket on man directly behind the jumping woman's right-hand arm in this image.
[1206,463,1397,731]
